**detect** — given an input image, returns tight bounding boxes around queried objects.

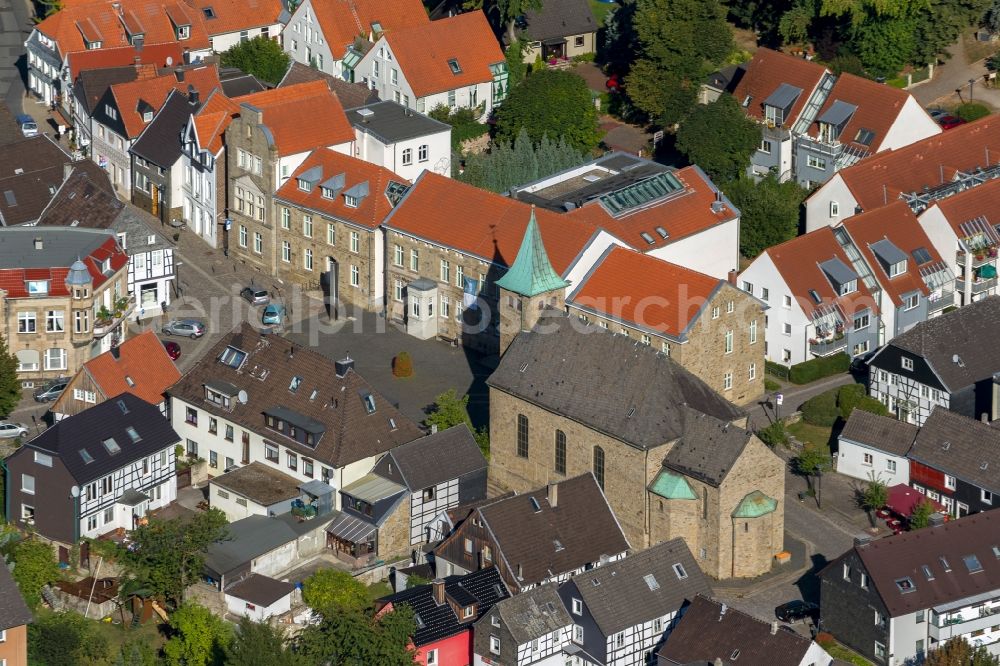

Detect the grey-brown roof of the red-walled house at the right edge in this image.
[908,407,1000,493]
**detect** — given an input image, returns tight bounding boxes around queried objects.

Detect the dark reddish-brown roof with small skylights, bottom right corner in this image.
[832,511,1000,617]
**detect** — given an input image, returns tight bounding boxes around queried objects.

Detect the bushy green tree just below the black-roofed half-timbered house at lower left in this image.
[122,509,229,605]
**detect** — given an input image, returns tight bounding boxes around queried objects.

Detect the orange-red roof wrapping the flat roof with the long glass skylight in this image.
[568,166,737,251]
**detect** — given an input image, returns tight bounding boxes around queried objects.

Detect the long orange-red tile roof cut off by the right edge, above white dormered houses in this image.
[834,116,1000,210]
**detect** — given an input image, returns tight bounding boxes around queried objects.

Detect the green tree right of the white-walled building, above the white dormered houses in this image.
[722,174,807,259]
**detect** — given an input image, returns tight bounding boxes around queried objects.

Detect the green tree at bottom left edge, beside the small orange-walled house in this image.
[28,611,110,666]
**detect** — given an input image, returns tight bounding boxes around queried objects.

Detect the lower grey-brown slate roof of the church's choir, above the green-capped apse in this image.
[663,408,753,487]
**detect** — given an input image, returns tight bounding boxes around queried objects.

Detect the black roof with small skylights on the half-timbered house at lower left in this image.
[23,393,181,484]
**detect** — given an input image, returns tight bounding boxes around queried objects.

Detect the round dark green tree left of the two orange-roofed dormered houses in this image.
[677,95,761,182]
